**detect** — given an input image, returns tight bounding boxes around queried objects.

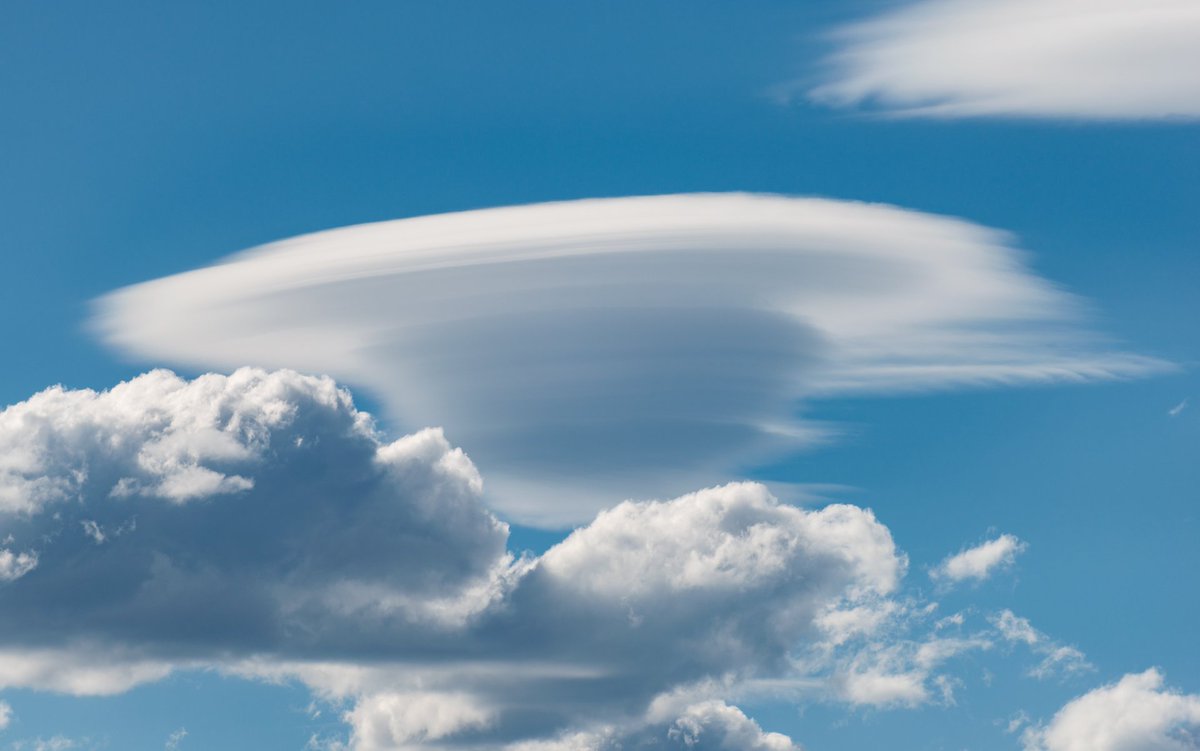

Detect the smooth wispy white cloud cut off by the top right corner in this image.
[809,0,1200,120]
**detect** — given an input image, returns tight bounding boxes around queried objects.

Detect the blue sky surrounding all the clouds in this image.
[0,0,1200,751]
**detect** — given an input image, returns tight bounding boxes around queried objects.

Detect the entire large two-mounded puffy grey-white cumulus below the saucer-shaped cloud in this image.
[0,368,906,751]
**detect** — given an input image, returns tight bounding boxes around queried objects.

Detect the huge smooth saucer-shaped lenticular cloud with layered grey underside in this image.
[94,194,1163,525]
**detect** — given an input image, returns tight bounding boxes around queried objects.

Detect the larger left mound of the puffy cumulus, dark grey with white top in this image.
[0,368,506,654]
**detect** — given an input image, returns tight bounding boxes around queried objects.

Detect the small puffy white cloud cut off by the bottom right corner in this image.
[1022,668,1200,751]
